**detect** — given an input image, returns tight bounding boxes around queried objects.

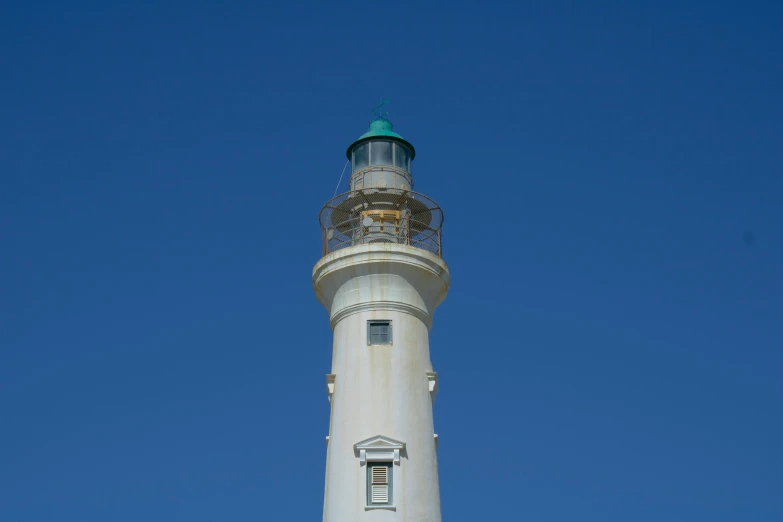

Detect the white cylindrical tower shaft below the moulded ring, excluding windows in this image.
[324,309,441,522]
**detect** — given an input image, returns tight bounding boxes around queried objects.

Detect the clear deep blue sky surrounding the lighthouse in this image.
[0,0,783,522]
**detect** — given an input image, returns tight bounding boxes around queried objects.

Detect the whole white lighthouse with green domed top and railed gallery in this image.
[313,106,449,522]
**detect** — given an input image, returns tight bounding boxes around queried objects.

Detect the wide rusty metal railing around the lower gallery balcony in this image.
[320,189,443,257]
